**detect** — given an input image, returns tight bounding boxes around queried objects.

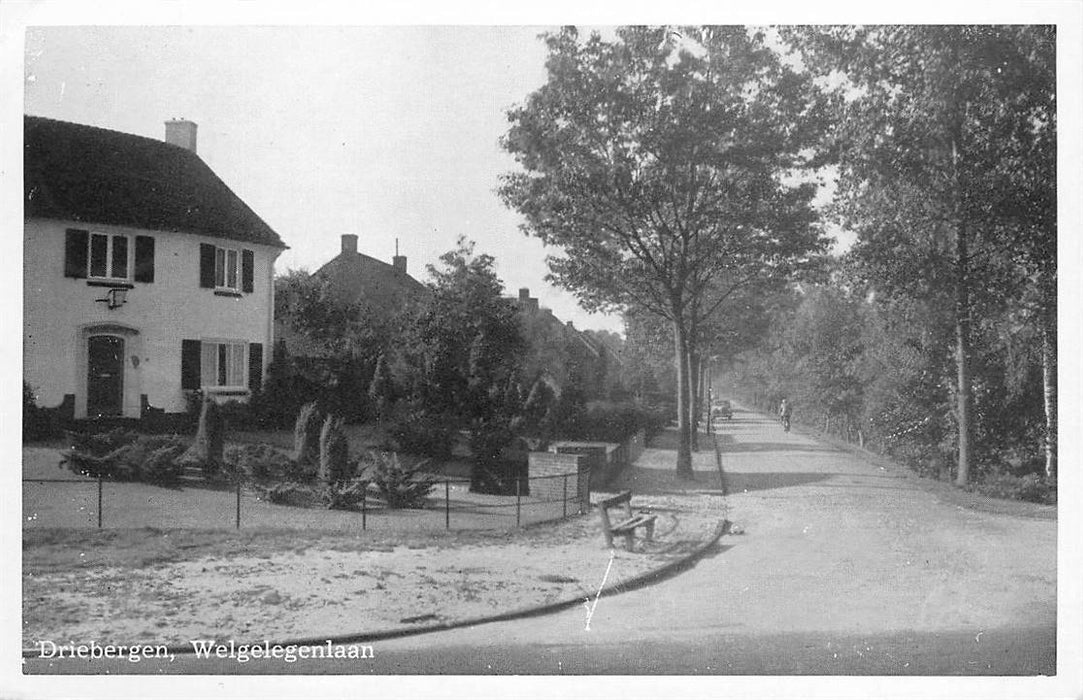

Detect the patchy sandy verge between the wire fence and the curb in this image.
[23,451,721,649]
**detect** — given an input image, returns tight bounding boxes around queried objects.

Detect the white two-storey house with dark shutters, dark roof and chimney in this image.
[23,116,286,419]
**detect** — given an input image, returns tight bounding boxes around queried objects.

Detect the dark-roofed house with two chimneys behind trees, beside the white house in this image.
[275,234,429,357]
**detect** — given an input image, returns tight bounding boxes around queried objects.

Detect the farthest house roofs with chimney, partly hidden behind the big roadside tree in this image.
[514,287,619,399]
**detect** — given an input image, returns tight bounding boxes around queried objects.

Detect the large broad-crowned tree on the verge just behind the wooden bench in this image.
[500,26,822,477]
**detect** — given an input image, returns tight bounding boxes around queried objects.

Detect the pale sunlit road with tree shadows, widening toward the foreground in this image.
[27,411,1056,675]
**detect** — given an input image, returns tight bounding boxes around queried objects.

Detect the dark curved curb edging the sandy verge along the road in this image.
[23,519,730,659]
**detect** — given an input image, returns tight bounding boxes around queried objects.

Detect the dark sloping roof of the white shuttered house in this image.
[23,115,287,248]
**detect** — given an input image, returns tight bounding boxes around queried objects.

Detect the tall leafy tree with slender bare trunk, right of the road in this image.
[785,26,1055,484]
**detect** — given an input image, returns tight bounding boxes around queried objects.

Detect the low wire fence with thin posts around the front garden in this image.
[23,474,590,531]
